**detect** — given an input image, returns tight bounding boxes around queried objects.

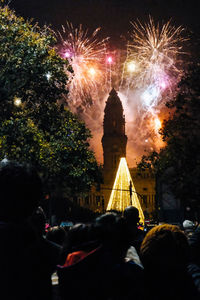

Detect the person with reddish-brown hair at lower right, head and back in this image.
[140,224,199,300]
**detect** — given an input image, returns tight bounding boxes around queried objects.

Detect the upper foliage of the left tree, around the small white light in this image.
[0,6,67,118]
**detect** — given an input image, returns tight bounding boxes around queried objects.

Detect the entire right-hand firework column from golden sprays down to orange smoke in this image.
[120,17,187,162]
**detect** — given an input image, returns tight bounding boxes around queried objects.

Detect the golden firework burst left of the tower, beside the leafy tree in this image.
[57,23,108,110]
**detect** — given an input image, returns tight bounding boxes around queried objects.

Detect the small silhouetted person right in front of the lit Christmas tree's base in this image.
[124,206,145,254]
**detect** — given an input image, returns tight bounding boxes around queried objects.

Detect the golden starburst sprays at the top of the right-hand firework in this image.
[127,17,187,84]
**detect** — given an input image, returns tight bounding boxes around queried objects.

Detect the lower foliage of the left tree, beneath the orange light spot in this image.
[0,104,98,194]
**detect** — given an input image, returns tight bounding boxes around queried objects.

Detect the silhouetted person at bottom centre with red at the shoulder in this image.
[58,213,143,300]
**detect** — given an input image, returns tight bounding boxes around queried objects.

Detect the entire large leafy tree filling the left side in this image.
[0,6,99,204]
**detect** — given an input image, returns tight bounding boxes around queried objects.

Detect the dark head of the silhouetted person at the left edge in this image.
[0,161,42,222]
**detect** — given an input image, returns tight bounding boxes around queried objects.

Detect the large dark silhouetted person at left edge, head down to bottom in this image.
[0,161,58,300]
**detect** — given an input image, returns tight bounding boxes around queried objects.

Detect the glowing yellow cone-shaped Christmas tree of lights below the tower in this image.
[107,157,144,224]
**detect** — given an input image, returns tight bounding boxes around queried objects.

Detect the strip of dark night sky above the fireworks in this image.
[10,0,200,44]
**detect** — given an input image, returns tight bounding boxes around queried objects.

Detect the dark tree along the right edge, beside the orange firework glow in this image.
[141,63,200,218]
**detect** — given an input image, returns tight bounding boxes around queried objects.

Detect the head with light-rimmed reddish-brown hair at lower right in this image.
[140,224,189,273]
